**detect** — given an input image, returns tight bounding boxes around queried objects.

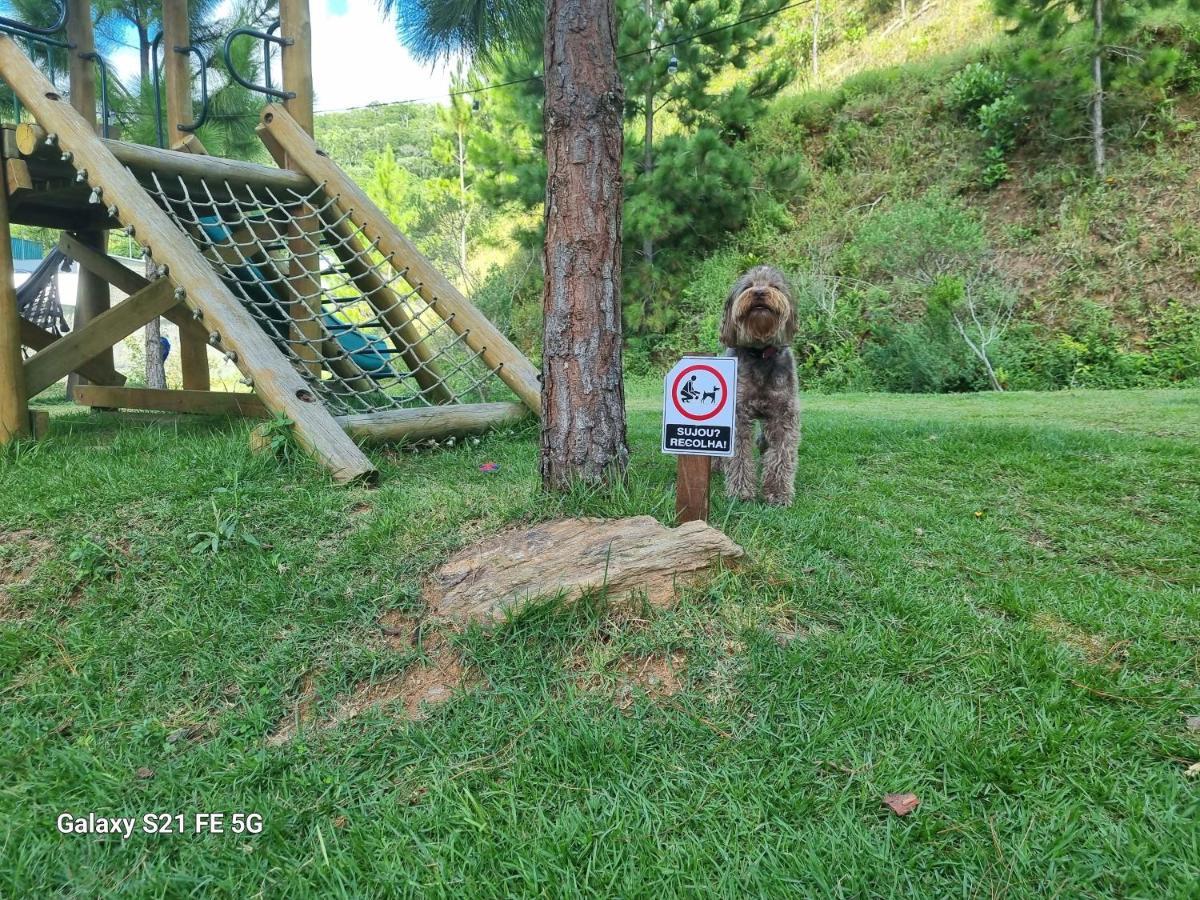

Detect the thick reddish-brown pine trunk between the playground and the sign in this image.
[541,0,629,490]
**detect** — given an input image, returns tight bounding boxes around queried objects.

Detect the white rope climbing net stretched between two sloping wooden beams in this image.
[143,172,510,415]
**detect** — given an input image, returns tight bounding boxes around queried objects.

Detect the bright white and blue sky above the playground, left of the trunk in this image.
[112,0,450,112]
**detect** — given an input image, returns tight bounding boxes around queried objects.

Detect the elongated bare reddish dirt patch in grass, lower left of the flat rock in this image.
[266,652,479,746]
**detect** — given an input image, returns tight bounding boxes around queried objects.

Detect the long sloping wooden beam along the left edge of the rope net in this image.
[0,36,377,481]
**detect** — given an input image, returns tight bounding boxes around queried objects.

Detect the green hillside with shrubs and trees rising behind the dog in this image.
[318,0,1200,391]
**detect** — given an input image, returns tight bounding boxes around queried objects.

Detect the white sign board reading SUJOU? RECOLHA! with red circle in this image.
[662,356,738,456]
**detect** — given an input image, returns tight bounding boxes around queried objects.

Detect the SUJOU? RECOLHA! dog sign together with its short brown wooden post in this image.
[662,356,738,523]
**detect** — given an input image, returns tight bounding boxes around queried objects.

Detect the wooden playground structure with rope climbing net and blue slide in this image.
[0,0,541,481]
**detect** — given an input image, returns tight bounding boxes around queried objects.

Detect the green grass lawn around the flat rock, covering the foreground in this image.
[0,386,1200,898]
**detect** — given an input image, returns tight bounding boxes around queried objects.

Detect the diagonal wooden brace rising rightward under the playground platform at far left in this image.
[25,278,178,397]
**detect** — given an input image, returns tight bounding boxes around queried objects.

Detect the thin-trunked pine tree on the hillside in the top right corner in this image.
[994,0,1200,175]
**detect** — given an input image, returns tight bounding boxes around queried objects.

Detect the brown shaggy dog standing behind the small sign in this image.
[721,265,800,506]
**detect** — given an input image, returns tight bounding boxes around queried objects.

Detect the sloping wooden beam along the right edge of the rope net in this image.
[263,104,541,414]
